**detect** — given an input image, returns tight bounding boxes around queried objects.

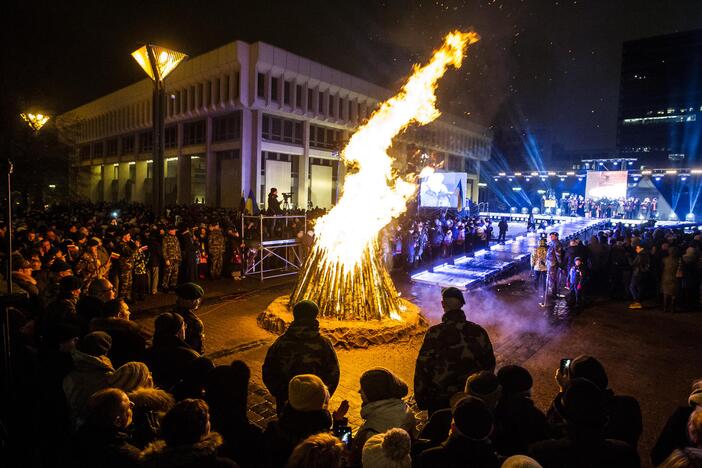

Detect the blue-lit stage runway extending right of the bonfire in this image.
[412,213,612,291]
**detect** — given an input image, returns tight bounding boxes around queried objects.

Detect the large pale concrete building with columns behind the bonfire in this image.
[57,41,492,207]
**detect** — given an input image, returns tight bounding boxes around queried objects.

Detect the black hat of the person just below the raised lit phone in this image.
[556,378,605,425]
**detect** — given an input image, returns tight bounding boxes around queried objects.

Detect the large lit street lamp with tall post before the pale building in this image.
[132,44,187,217]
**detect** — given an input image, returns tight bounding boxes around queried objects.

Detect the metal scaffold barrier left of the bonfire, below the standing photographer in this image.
[241,215,307,281]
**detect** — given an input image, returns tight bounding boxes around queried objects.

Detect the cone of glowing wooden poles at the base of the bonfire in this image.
[290,241,403,320]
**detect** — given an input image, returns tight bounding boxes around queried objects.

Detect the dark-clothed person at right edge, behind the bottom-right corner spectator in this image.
[651,379,702,466]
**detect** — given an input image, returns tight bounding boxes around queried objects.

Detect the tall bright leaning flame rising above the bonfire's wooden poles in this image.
[315,31,478,269]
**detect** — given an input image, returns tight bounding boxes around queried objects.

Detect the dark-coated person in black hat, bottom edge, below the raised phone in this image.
[529,378,640,468]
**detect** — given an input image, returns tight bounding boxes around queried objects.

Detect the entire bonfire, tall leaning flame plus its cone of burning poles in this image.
[290,31,479,320]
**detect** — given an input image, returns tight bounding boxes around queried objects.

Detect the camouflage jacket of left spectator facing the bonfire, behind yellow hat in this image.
[263,321,339,402]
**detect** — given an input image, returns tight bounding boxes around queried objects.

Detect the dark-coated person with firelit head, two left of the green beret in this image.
[90,298,149,368]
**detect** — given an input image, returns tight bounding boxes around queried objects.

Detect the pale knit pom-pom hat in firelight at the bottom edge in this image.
[361,428,412,468]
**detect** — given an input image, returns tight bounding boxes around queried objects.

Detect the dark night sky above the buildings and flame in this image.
[2,0,702,149]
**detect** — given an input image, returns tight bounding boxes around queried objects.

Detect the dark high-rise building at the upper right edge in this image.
[617,30,702,167]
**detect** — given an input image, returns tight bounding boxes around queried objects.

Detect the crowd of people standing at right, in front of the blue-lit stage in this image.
[531,223,702,313]
